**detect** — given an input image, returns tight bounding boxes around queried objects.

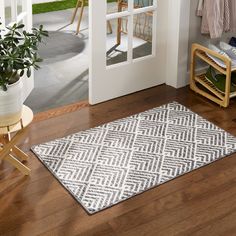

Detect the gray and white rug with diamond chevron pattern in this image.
[32,102,236,214]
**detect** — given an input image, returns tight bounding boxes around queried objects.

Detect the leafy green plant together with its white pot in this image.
[0,22,48,127]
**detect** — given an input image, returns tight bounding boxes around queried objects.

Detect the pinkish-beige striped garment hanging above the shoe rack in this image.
[197,0,230,38]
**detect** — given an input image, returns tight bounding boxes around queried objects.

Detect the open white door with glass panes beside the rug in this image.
[89,0,169,104]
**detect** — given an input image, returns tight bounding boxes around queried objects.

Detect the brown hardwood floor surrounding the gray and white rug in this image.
[0,85,236,236]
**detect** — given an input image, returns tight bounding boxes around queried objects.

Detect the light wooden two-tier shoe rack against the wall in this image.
[190,44,236,107]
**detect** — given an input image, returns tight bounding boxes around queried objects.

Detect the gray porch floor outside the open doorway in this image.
[25,8,89,112]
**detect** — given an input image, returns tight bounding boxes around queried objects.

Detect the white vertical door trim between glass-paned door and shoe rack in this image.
[166,0,191,88]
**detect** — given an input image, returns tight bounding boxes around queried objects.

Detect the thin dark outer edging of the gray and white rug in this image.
[30,101,236,216]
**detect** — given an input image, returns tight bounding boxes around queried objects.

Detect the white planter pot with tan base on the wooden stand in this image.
[0,79,23,127]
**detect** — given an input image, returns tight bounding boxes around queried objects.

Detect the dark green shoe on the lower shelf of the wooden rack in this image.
[205,66,236,93]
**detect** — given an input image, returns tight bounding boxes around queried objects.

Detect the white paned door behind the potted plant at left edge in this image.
[0,0,34,99]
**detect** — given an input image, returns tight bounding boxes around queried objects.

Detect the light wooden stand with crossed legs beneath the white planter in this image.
[0,106,34,175]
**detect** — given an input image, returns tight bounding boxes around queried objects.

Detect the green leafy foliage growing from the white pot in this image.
[0,22,48,91]
